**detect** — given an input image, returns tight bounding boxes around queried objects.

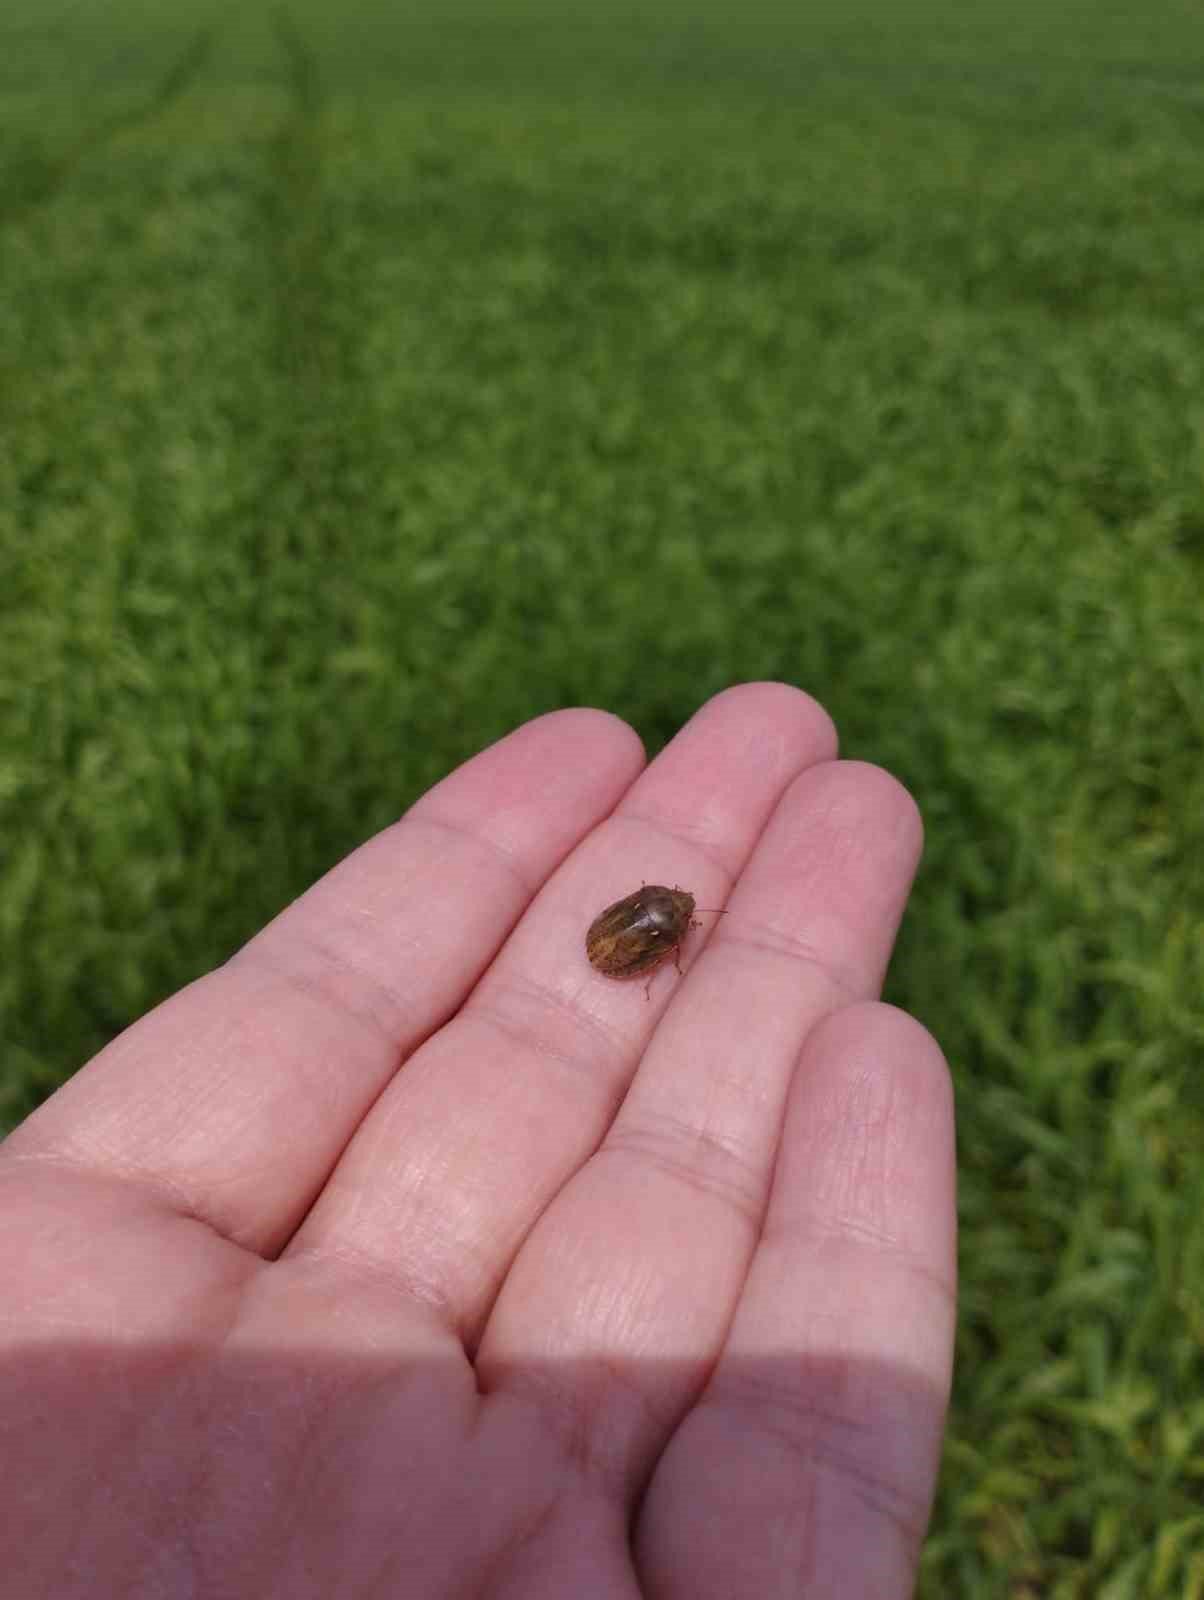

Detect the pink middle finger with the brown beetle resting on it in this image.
[290,683,834,1344]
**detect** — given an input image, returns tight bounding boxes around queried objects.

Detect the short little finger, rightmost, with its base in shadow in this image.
[637,1006,956,1600]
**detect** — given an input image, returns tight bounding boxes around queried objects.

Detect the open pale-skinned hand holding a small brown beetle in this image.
[0,683,954,1600]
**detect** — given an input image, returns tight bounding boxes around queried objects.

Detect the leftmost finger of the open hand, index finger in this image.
[5,710,642,1253]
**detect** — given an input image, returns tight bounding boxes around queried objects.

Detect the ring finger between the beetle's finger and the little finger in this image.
[479,762,919,1493]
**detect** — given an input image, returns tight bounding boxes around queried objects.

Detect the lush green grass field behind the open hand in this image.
[0,0,1204,1600]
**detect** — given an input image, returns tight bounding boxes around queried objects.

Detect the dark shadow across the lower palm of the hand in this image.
[0,1328,945,1600]
